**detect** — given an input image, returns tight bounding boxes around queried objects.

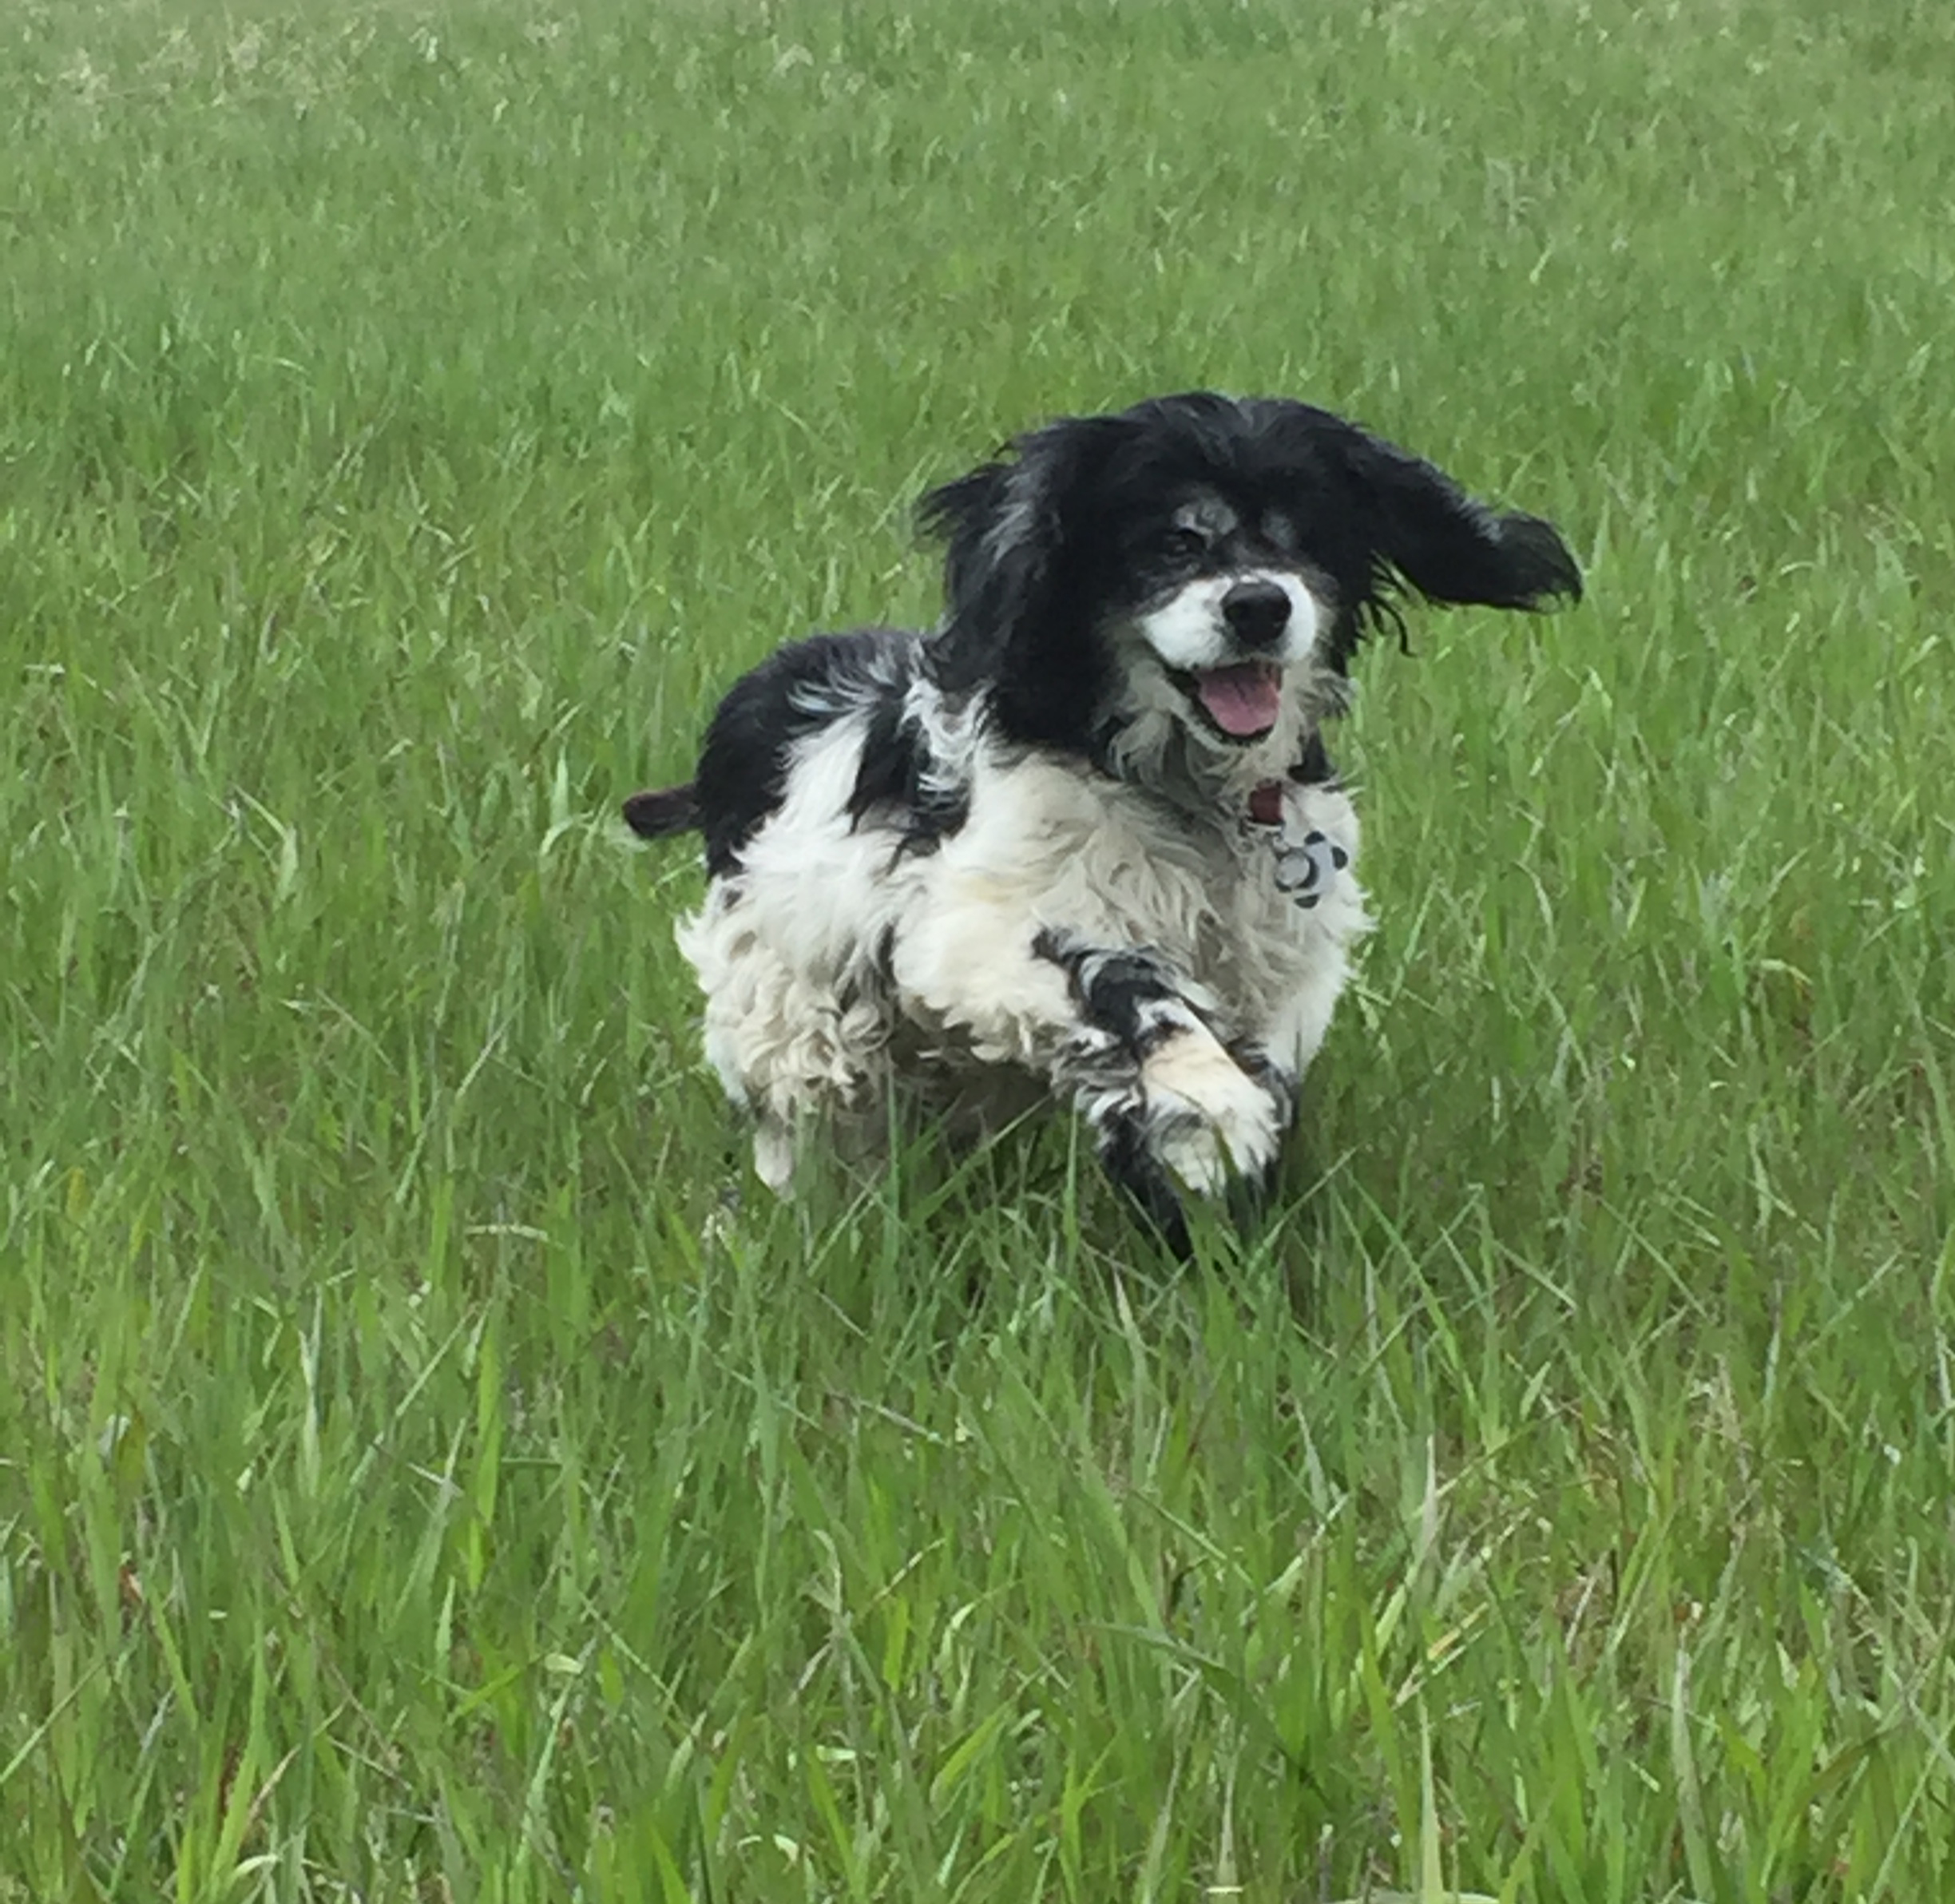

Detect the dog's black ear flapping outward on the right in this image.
[1345,430,1581,608]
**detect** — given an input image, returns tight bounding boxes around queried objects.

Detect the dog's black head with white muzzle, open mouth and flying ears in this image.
[922,393,1581,784]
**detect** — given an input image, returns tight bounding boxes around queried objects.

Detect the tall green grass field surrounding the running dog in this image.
[0,0,1955,1904]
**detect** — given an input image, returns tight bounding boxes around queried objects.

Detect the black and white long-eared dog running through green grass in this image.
[625,393,1581,1248]
